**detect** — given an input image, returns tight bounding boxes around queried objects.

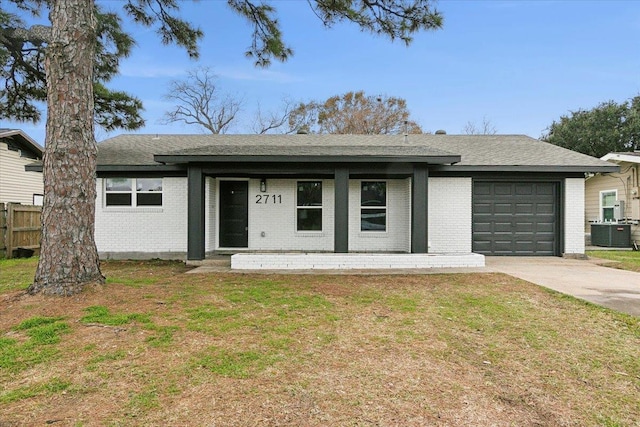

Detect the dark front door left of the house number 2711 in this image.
[219,181,249,248]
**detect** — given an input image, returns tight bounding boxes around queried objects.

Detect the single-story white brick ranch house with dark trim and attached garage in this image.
[79,134,618,268]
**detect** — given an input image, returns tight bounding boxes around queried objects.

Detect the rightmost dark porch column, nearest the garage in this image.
[411,164,429,254]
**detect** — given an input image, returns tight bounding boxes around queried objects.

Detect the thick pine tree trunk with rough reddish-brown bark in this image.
[28,0,104,295]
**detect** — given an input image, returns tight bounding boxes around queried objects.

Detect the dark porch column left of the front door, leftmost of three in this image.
[187,165,204,260]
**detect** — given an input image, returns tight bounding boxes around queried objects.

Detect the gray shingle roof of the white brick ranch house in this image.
[98,134,612,172]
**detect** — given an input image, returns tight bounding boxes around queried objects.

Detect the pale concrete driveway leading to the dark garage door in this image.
[485,257,640,316]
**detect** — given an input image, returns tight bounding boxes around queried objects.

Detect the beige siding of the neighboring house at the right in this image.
[584,162,640,246]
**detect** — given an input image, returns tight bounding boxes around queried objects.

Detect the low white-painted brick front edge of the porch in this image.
[231,253,485,270]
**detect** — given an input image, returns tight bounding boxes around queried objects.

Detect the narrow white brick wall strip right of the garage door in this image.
[564,178,585,255]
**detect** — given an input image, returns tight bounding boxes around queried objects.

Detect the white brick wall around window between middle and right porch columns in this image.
[349,179,411,252]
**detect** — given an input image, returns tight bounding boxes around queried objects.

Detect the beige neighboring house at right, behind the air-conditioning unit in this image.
[585,152,640,247]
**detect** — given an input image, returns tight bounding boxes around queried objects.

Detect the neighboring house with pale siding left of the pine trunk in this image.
[0,129,44,205]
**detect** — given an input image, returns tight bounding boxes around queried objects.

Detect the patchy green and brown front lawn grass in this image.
[0,260,640,426]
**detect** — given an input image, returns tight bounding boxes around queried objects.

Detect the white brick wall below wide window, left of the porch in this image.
[95,178,187,257]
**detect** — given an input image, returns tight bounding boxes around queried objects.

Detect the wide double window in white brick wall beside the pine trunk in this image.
[104,178,162,207]
